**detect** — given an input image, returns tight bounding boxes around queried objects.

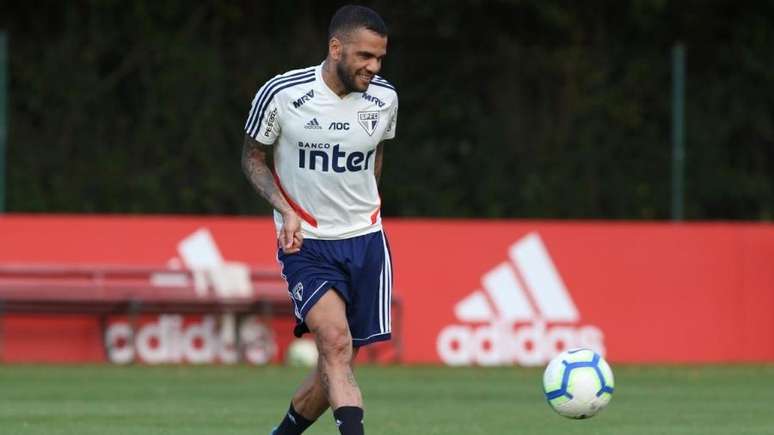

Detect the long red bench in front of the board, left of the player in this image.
[0,264,402,362]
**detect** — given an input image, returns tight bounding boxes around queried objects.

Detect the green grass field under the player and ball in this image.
[0,365,774,435]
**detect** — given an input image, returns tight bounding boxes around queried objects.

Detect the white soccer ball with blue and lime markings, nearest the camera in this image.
[543,349,614,419]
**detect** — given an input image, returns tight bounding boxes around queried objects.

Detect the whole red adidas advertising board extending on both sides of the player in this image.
[0,215,774,365]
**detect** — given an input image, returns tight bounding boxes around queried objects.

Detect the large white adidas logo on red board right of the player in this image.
[436,233,605,366]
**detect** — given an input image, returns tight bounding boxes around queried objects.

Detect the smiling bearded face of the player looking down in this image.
[336,28,387,92]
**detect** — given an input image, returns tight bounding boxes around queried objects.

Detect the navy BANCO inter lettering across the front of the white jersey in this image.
[298,142,374,172]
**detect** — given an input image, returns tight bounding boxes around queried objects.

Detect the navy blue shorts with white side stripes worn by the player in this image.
[277,231,392,347]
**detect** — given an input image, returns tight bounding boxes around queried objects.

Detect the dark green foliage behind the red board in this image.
[0,0,774,220]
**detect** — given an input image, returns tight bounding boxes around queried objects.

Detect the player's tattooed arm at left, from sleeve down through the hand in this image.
[242,135,303,254]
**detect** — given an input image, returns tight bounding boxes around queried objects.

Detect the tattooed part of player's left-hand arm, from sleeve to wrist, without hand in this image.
[242,135,291,213]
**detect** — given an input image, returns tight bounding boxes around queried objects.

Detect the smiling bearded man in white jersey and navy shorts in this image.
[242,6,398,435]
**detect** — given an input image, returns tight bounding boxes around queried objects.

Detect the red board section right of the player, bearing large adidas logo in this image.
[393,221,774,364]
